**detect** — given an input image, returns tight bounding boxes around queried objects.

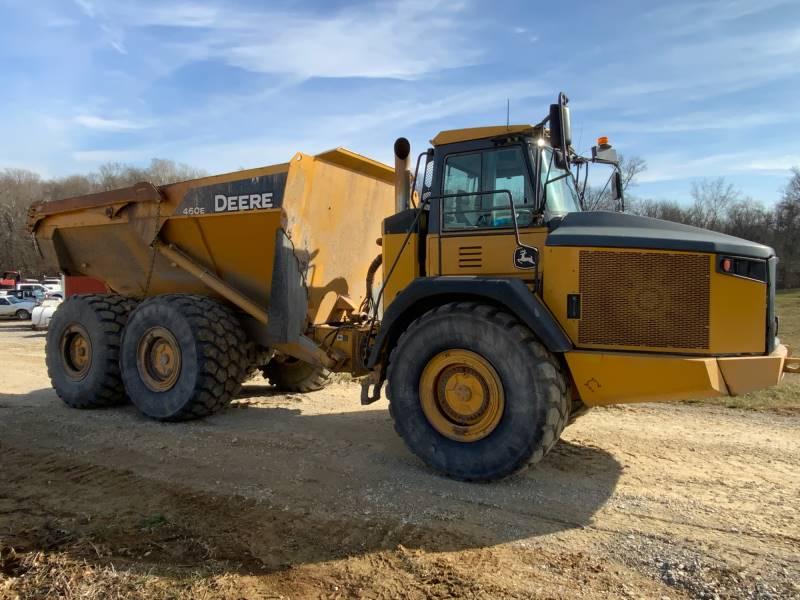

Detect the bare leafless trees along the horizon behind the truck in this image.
[0,157,800,288]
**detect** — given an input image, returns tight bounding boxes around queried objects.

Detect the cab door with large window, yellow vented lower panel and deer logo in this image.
[426,145,547,283]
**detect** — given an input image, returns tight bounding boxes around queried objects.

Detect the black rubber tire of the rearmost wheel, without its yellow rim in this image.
[45,294,136,408]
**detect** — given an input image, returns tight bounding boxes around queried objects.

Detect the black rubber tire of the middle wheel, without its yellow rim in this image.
[120,294,249,421]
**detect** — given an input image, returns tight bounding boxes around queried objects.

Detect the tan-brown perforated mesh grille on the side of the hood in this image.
[578,250,710,349]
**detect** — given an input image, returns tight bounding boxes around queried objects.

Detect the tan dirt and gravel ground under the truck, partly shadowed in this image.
[0,322,800,598]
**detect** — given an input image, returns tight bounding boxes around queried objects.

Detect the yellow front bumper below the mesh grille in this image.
[564,344,800,406]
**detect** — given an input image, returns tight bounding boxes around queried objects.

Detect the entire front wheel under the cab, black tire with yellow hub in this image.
[387,302,570,481]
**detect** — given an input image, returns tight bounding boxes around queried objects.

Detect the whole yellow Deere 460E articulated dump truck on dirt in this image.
[29,94,800,481]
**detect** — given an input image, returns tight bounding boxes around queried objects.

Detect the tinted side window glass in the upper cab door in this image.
[442,146,533,230]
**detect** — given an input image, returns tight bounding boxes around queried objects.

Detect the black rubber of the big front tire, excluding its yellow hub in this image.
[387,302,571,481]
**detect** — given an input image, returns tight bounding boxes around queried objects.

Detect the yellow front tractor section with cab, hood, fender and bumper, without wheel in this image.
[378,110,790,406]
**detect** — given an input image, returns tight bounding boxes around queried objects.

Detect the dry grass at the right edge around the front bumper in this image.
[687,290,800,413]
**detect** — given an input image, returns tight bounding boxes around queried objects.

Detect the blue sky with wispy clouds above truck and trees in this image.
[0,0,800,203]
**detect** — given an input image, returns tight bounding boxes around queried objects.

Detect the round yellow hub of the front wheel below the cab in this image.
[420,350,505,442]
